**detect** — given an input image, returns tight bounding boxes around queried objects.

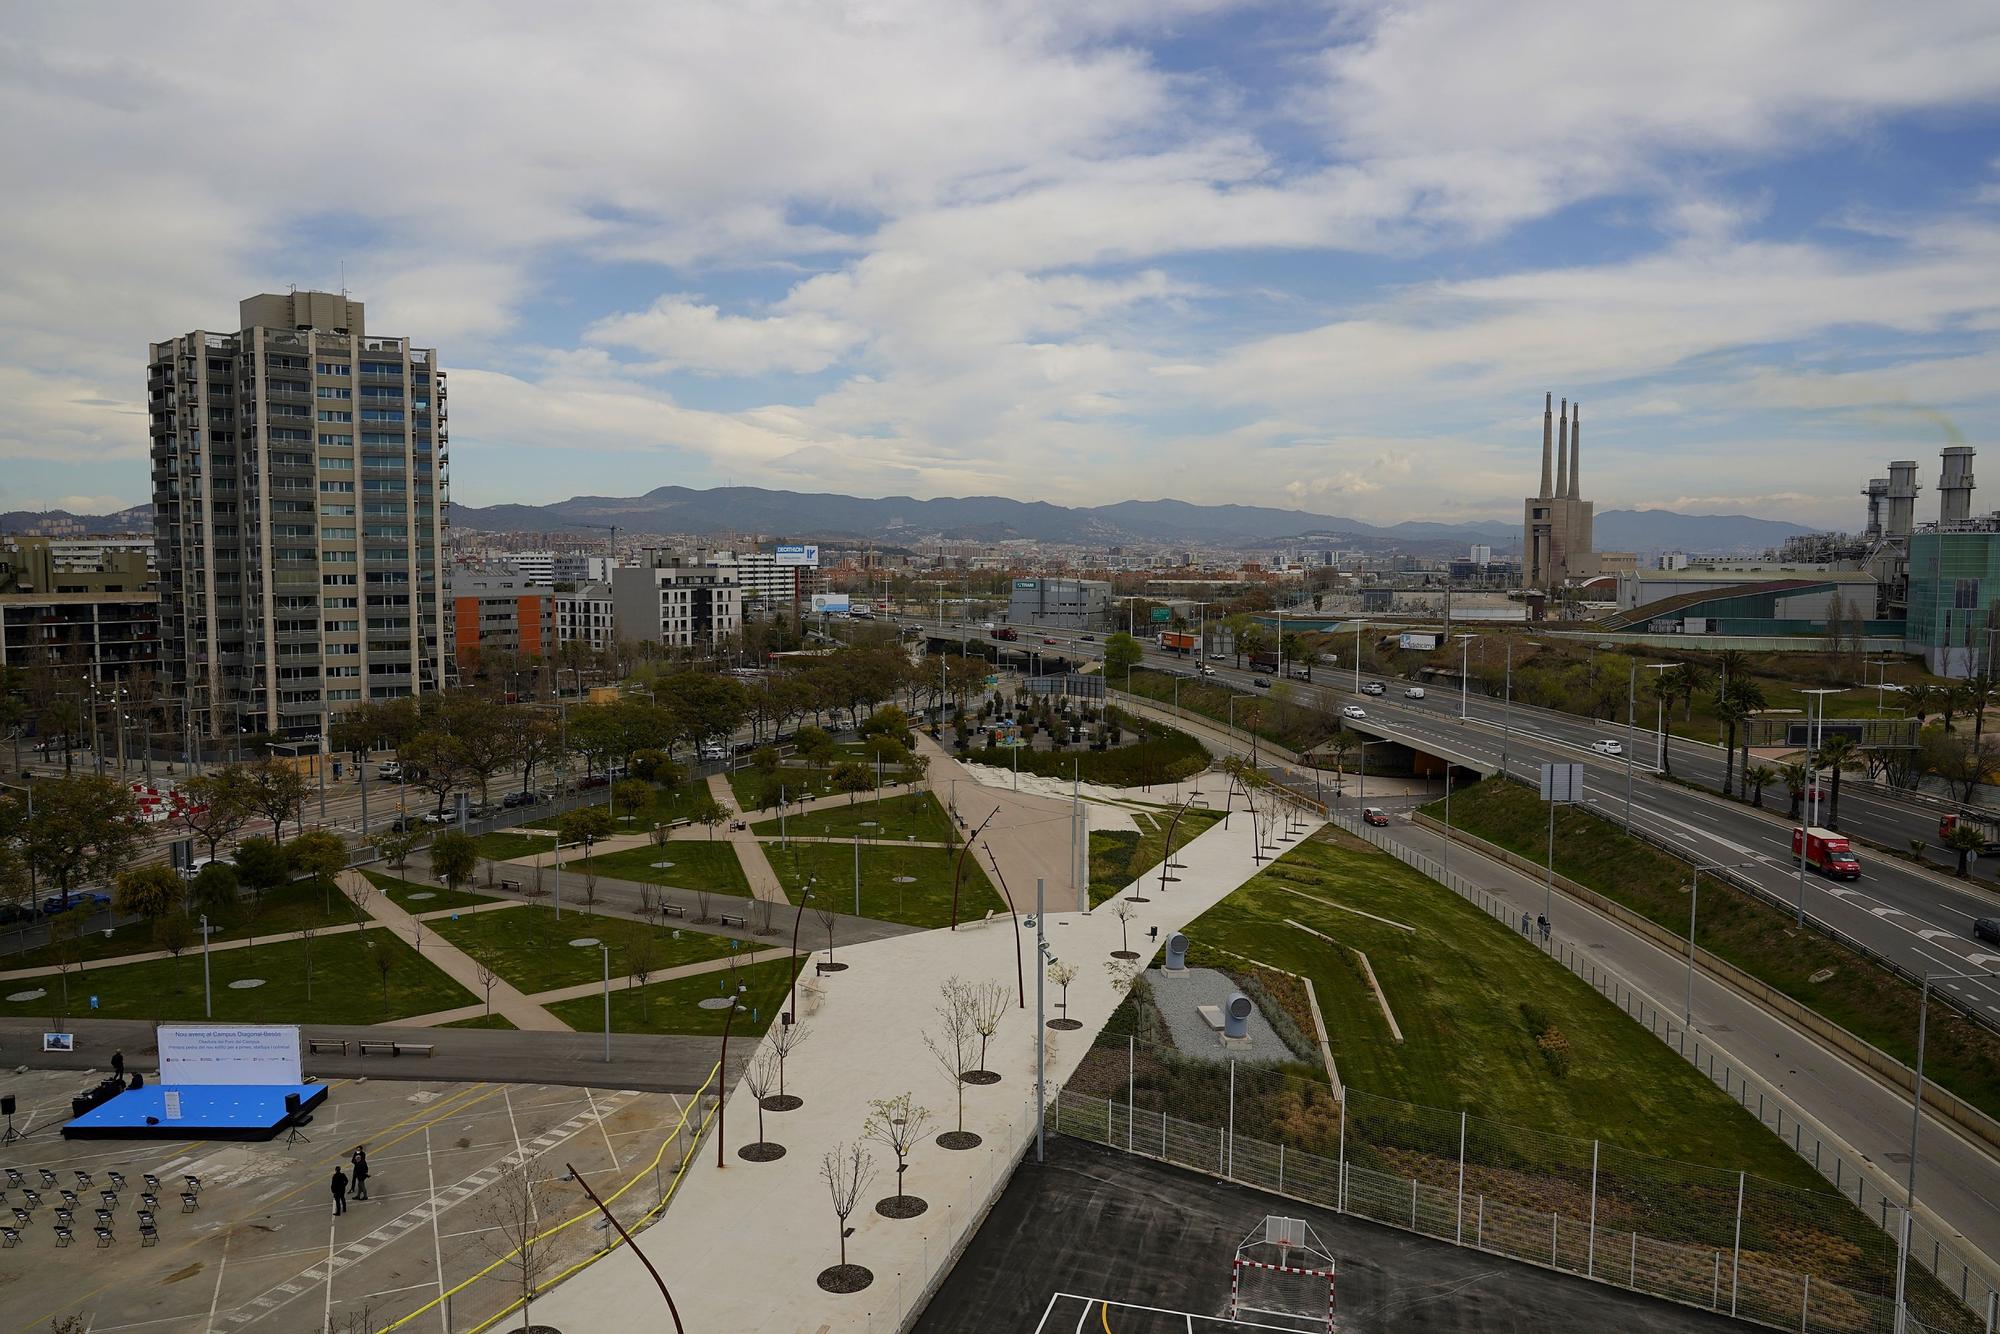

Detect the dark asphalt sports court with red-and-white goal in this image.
[916,1136,1742,1334]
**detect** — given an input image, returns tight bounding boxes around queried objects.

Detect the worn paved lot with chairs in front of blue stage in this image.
[0,1070,696,1334]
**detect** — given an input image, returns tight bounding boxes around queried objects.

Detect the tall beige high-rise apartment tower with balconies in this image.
[146,292,450,736]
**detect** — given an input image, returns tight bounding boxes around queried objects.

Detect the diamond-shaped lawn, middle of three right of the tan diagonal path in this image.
[424,904,754,1008]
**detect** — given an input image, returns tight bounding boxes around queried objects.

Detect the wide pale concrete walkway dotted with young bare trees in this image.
[534,800,1296,1334]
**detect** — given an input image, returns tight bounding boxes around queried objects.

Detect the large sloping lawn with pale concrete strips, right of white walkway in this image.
[1188,840,1826,1190]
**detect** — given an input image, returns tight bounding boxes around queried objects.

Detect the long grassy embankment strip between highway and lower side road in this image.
[1426,782,2000,1116]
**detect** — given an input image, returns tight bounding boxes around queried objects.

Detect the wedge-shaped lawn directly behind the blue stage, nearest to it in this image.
[0,928,478,1024]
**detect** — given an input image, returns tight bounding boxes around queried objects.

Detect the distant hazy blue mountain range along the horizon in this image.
[0,486,1810,554]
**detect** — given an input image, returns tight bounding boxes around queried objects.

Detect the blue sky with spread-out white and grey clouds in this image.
[0,0,2000,530]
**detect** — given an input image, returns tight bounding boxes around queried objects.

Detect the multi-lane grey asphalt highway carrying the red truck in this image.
[910,618,2000,1024]
